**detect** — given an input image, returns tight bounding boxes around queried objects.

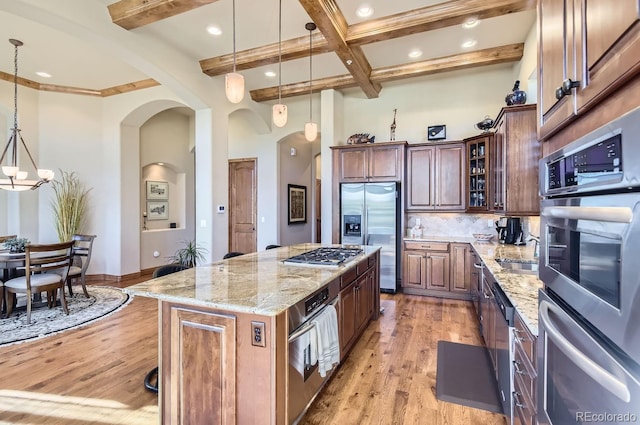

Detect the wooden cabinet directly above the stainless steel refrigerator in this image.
[331,142,407,183]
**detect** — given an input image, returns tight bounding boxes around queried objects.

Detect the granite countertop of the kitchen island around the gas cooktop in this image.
[123,244,380,316]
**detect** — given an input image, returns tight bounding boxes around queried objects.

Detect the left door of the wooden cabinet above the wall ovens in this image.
[538,0,580,138]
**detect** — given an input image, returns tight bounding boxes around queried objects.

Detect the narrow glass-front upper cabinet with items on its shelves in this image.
[465,132,494,211]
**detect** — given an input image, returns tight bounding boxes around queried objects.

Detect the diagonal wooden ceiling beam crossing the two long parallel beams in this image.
[300,0,382,99]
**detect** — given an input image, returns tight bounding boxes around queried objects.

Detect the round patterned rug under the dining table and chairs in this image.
[0,286,130,347]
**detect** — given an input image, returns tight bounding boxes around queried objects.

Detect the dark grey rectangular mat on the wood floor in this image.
[436,341,503,413]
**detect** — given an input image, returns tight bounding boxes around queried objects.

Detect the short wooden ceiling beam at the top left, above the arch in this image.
[107,0,217,30]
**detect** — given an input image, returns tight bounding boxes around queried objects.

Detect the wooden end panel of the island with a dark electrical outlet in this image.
[159,301,287,425]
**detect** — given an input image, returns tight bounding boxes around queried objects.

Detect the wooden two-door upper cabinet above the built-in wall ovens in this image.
[538,0,640,140]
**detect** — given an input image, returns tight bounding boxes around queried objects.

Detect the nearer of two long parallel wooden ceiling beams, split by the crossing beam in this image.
[200,0,535,77]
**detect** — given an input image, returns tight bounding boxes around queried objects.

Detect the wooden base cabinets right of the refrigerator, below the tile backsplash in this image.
[402,241,471,299]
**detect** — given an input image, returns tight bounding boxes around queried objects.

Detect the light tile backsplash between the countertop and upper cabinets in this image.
[405,213,540,237]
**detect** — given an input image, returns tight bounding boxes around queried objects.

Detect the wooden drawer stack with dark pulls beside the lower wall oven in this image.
[512,311,537,425]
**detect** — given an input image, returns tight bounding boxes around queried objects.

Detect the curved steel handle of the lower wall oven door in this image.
[539,300,631,403]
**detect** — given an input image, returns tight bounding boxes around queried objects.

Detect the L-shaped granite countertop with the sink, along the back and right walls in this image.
[404,235,543,336]
